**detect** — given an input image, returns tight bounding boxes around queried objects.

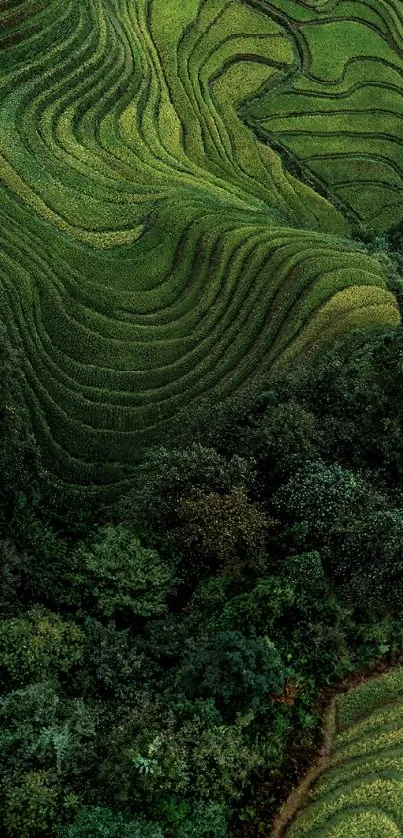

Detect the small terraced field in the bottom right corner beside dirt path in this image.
[286,668,403,838]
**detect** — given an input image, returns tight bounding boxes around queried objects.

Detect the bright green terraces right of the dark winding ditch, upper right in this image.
[246,0,403,231]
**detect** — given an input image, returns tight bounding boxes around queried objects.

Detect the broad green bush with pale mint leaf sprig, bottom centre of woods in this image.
[98,686,262,822]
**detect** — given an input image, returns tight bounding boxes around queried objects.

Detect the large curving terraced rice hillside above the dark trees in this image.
[0,0,403,492]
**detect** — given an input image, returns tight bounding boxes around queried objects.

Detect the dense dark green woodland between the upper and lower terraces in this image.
[0,306,403,838]
